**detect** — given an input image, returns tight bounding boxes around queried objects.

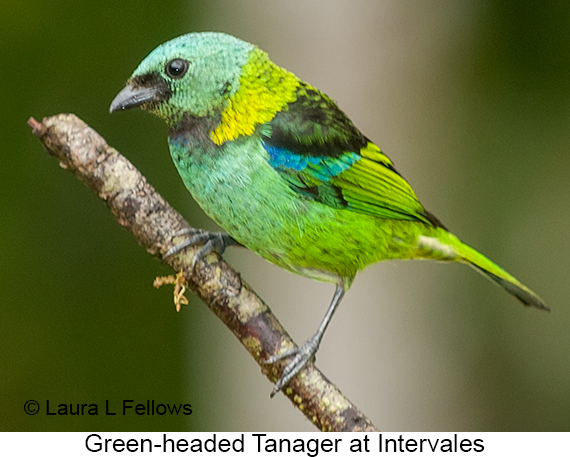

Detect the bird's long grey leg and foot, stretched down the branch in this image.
[264,279,346,397]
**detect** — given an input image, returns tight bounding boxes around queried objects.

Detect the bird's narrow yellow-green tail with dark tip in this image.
[422,232,550,311]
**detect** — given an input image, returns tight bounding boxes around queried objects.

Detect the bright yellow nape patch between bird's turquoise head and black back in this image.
[210,48,300,144]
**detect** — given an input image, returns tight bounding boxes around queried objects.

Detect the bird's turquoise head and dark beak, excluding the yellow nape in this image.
[110,33,255,125]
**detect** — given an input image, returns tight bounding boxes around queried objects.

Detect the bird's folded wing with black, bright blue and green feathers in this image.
[262,85,441,226]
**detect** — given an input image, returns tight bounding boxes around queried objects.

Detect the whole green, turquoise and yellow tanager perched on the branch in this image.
[110,32,549,396]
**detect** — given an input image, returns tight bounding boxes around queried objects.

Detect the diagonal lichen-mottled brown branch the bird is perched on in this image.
[28,114,378,431]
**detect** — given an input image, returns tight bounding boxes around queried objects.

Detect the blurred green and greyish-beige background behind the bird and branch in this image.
[0,0,570,431]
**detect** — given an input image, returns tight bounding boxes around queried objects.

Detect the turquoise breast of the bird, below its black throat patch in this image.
[166,137,307,256]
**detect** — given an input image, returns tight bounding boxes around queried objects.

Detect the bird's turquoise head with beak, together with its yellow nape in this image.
[110,32,301,145]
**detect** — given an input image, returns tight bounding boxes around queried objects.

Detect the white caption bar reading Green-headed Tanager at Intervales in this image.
[0,432,570,457]
